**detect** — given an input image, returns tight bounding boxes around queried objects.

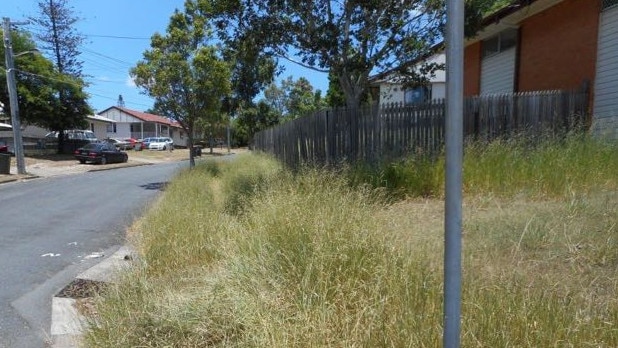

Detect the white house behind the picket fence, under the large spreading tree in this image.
[369,52,446,105]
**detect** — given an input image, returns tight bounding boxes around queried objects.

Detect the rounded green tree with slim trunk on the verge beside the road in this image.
[131,0,231,167]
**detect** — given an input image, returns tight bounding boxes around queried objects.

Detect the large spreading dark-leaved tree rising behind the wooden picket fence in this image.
[214,0,444,107]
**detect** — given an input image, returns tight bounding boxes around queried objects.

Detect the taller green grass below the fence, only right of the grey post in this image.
[464,135,618,198]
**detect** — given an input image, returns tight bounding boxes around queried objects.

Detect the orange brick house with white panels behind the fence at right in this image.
[464,0,618,139]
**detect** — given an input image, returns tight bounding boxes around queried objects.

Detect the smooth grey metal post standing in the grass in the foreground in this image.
[443,0,464,348]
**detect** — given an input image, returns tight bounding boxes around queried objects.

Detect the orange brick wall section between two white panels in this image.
[517,0,600,91]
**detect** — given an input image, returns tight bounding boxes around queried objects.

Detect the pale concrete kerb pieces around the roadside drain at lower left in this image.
[50,246,135,348]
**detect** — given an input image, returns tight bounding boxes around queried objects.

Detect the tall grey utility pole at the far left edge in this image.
[2,17,26,174]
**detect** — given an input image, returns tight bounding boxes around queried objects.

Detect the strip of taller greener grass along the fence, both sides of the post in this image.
[348,135,618,199]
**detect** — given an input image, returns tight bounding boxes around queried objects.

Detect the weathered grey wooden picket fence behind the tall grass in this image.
[253,91,588,167]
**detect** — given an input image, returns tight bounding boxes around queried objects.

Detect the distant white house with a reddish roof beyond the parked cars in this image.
[99,106,187,147]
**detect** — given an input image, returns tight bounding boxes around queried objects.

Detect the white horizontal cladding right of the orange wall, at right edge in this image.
[594,6,618,136]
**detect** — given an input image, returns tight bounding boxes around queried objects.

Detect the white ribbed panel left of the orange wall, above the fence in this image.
[481,47,516,94]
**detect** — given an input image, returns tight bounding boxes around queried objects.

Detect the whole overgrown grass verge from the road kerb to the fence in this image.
[85,138,618,347]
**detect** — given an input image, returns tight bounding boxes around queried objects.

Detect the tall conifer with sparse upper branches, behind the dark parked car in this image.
[29,0,93,152]
